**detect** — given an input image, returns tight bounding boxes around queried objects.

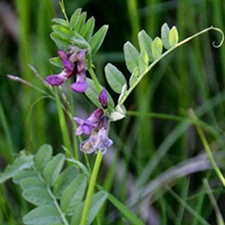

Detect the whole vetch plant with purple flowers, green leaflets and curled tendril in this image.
[0,1,224,225]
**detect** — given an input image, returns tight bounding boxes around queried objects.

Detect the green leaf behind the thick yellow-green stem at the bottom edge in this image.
[71,191,108,225]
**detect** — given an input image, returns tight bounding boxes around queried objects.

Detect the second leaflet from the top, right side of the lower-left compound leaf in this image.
[43,153,65,185]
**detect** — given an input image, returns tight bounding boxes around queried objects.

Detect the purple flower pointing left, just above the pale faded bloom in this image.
[74,108,103,135]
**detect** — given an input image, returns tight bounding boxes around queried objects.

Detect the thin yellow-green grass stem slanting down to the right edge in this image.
[190,110,225,187]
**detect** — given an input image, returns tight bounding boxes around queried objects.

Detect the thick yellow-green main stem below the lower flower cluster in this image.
[80,151,102,225]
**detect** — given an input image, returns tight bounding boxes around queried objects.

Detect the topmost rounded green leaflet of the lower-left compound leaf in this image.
[34,144,52,171]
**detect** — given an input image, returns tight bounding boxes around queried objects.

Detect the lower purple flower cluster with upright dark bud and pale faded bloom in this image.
[74,89,113,154]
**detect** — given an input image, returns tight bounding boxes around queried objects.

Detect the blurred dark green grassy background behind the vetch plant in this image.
[0,0,225,225]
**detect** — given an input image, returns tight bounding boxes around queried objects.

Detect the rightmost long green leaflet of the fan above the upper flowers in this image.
[89,25,108,56]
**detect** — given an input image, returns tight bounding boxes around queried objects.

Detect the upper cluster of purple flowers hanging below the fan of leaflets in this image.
[45,47,87,93]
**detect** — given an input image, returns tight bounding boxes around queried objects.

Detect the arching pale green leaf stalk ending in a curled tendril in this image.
[118,26,224,105]
